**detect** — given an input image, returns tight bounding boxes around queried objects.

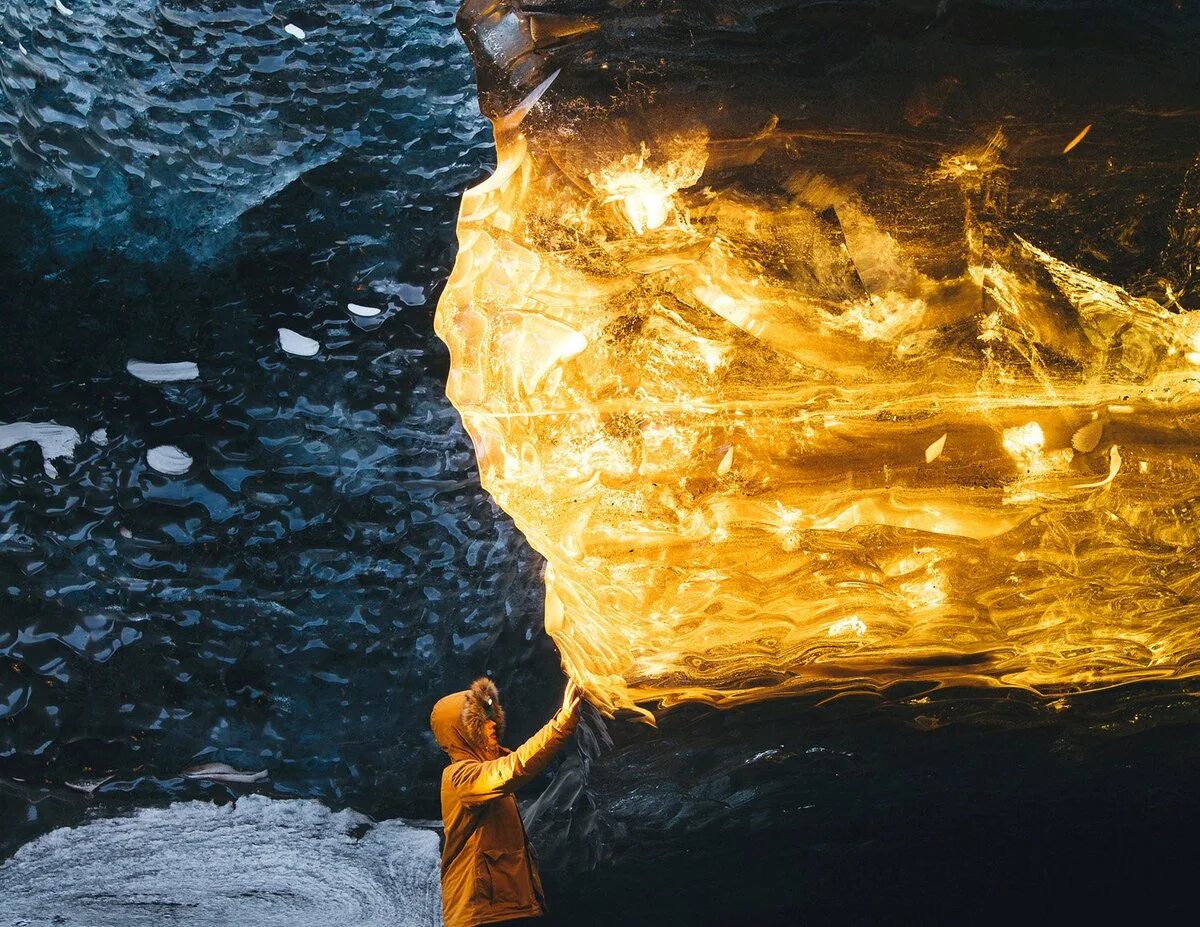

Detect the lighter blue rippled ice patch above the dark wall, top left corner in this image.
[0,0,487,253]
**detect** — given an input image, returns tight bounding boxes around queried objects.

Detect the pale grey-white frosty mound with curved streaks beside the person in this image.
[0,795,440,927]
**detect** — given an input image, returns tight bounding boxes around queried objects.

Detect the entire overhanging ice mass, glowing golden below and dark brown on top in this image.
[437,0,1200,710]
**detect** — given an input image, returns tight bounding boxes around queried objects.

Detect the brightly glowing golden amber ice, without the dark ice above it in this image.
[437,120,1200,710]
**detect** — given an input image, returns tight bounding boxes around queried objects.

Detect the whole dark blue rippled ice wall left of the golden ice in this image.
[0,0,560,859]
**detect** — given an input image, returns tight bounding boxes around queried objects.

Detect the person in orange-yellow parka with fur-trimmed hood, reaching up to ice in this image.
[430,677,580,927]
